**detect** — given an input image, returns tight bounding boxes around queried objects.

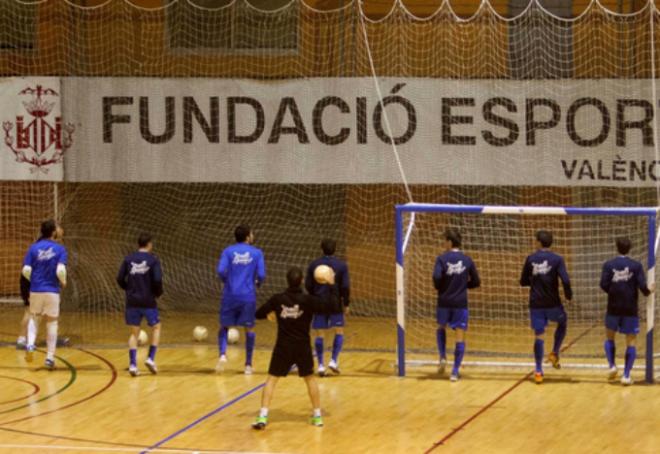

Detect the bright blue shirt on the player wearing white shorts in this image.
[23,239,67,293]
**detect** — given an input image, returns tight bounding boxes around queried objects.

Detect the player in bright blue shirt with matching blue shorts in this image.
[215,225,266,375]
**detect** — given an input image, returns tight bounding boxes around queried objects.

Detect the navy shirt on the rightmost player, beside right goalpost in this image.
[600,256,651,317]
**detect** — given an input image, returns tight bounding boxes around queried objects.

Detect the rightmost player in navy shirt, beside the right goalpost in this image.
[600,238,655,385]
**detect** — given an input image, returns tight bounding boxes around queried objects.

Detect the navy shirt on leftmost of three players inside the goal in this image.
[433,249,481,309]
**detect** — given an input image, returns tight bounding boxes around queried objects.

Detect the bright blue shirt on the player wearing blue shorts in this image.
[217,243,266,303]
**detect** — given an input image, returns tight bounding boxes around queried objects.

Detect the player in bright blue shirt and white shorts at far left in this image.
[22,219,67,370]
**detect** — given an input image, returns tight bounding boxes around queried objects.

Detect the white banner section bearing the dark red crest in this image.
[0,77,65,181]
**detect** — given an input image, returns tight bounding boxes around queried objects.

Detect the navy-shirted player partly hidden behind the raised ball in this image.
[305,238,351,376]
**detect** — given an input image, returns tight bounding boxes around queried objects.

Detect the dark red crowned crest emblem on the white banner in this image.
[2,85,75,173]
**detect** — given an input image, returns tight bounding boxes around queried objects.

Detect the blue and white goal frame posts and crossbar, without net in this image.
[395,203,660,383]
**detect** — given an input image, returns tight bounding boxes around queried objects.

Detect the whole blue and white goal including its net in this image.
[395,203,658,383]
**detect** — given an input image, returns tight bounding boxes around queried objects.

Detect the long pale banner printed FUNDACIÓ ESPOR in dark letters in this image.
[2,78,660,186]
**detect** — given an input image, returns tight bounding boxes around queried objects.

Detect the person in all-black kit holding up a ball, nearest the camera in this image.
[252,267,342,430]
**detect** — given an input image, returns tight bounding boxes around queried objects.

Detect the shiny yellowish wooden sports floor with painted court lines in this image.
[0,306,660,454]
